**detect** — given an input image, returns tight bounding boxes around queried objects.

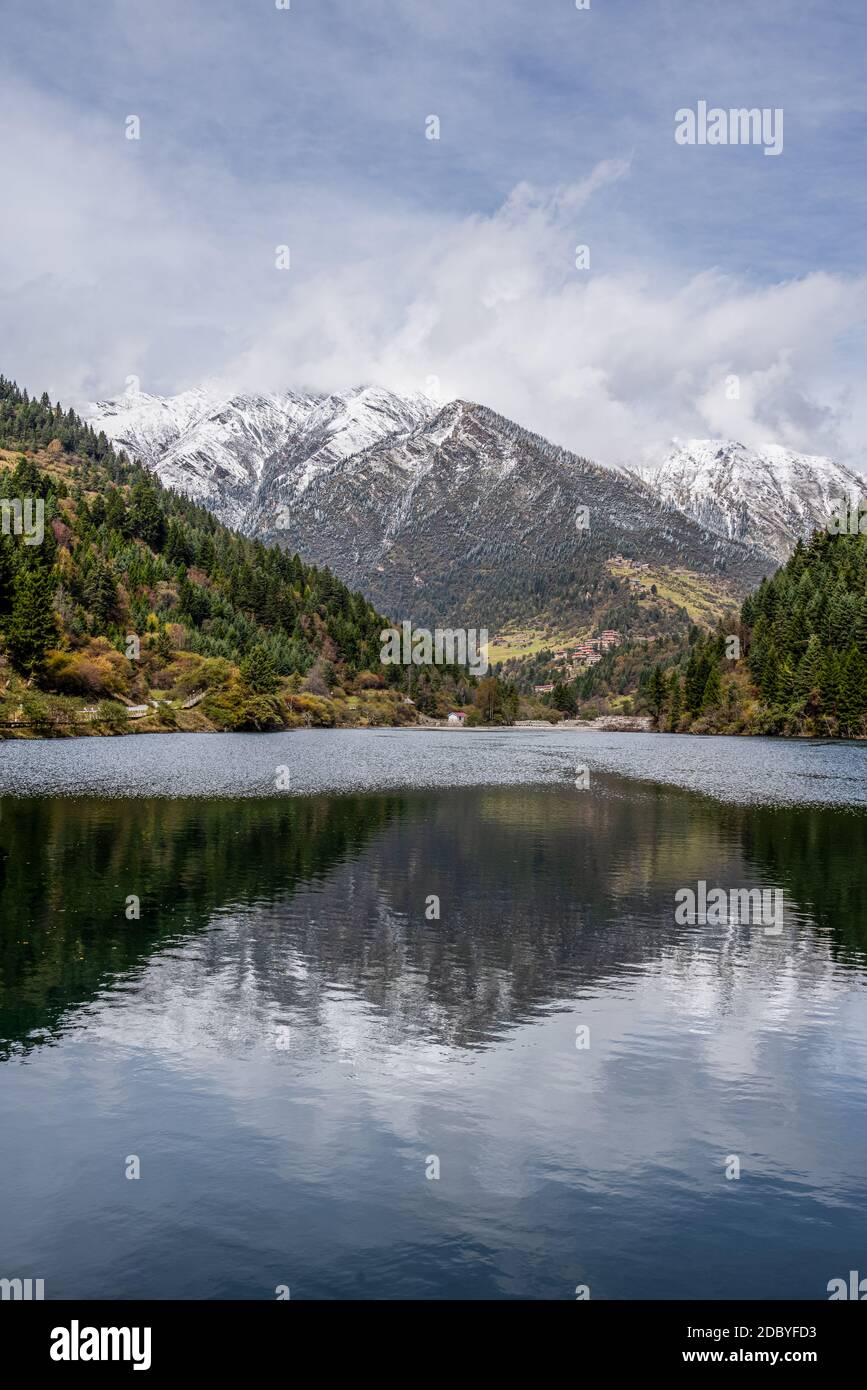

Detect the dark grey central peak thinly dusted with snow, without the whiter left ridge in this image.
[250,400,770,630]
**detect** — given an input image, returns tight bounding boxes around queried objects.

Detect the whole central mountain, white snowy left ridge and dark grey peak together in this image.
[89,388,774,630]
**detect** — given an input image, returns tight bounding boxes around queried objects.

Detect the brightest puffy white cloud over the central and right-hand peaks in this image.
[226,177,867,463]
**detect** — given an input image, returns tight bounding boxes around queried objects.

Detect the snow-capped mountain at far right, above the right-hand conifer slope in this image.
[642,439,867,564]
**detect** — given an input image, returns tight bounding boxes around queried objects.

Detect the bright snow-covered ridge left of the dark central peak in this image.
[85,386,436,531]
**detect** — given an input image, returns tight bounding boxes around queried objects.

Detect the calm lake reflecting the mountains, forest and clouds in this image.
[0,730,867,1300]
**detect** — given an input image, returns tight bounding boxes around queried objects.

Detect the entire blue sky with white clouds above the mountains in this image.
[0,0,867,468]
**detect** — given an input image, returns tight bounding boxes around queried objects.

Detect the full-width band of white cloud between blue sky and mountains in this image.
[0,85,867,464]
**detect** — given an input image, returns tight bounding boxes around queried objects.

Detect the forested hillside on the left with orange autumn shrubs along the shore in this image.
[0,378,439,731]
